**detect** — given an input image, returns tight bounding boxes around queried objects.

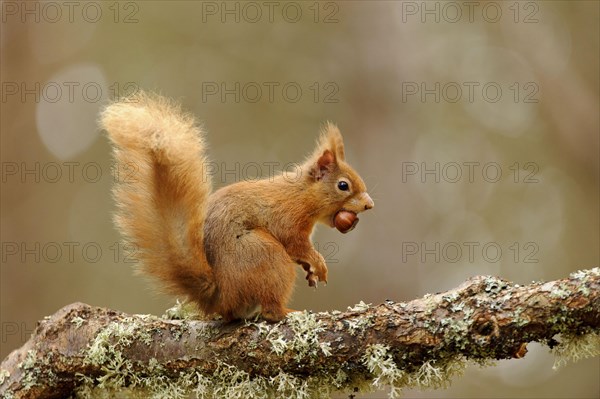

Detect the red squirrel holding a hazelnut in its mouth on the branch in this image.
[101,92,374,321]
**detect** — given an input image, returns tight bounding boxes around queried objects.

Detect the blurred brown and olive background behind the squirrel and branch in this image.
[0,1,600,398]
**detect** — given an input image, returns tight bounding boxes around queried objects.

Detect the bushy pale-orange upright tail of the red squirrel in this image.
[101,93,216,312]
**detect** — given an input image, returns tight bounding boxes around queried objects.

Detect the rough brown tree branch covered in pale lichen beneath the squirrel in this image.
[0,268,600,398]
